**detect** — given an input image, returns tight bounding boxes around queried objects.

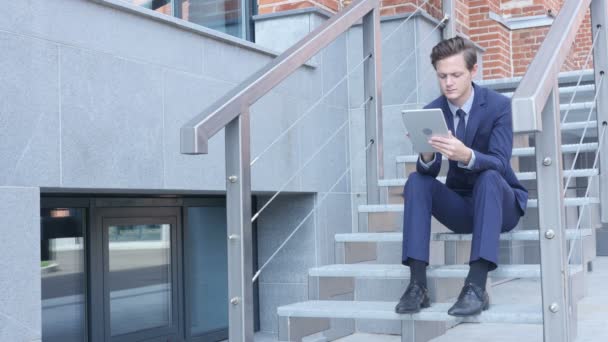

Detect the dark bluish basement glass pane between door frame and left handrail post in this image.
[185,207,228,336]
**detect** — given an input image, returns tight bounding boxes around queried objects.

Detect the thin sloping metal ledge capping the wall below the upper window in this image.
[89,0,316,69]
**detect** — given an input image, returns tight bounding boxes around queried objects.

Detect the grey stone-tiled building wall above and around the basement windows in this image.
[0,0,352,341]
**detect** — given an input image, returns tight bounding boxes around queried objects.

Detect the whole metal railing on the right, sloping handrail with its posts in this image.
[512,0,608,342]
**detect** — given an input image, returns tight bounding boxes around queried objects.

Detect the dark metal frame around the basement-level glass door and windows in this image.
[40,192,260,342]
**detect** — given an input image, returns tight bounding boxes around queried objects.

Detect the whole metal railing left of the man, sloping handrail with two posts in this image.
[181,0,383,341]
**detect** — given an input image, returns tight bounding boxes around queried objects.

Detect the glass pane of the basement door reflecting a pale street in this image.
[108,224,173,336]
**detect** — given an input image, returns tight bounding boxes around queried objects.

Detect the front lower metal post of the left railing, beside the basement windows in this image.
[226,108,253,342]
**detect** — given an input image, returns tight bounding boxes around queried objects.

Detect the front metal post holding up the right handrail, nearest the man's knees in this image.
[536,84,576,342]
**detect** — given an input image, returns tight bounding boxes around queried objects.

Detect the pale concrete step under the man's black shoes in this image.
[277,301,542,324]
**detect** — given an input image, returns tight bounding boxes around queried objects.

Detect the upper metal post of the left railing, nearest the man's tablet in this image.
[363,2,384,204]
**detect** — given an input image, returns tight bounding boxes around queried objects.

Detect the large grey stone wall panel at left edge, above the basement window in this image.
[0,32,60,186]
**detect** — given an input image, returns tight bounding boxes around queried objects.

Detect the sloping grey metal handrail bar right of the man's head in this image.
[512,0,591,133]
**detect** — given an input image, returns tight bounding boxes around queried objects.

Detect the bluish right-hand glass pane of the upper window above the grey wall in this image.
[182,0,245,38]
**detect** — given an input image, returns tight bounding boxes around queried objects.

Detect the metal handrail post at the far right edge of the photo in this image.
[591,0,608,223]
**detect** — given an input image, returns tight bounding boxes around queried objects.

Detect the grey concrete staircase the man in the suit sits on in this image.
[277,72,599,342]
